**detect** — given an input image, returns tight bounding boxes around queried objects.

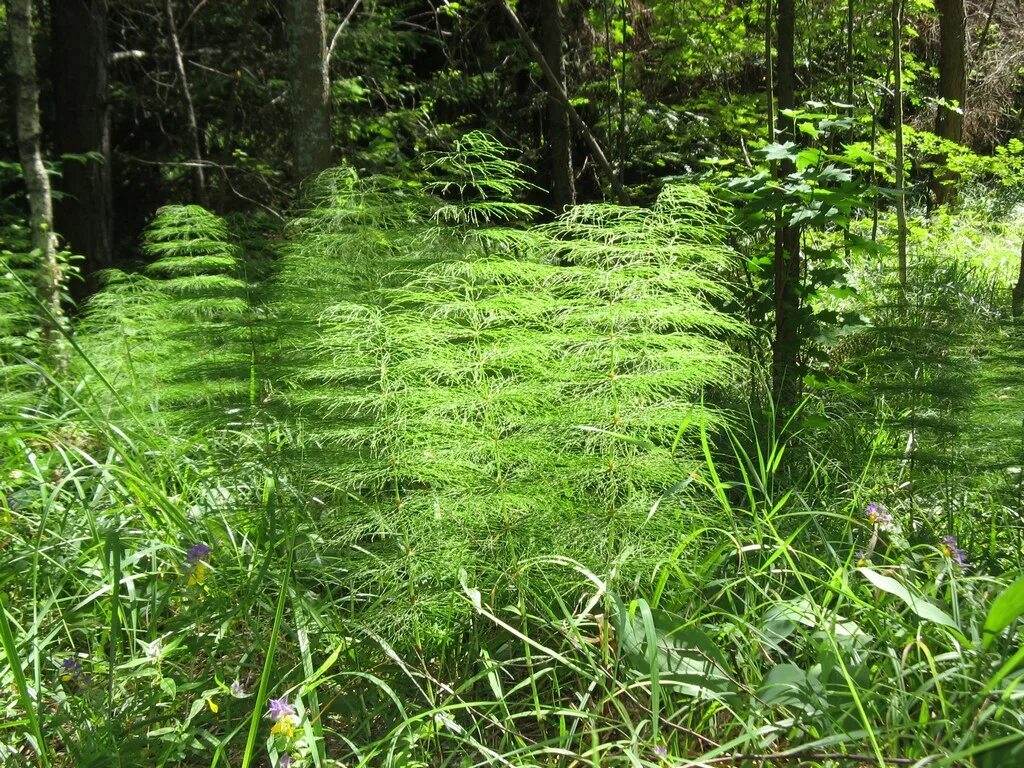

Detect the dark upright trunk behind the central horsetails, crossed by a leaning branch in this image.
[540,0,575,212]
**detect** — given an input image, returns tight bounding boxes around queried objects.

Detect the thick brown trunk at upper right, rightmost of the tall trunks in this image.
[932,0,967,204]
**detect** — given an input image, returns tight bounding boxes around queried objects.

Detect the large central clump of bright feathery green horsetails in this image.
[280,134,743,651]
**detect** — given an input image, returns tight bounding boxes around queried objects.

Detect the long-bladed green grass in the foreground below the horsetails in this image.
[6,393,1024,766]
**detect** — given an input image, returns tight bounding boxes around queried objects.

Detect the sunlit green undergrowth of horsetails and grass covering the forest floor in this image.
[0,140,1024,768]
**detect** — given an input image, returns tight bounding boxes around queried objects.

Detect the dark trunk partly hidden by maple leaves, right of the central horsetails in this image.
[772,0,802,425]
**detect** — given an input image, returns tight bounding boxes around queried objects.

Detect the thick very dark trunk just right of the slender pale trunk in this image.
[50,0,114,286]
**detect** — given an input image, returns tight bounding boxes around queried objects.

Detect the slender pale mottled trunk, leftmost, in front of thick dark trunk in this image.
[7,0,68,370]
